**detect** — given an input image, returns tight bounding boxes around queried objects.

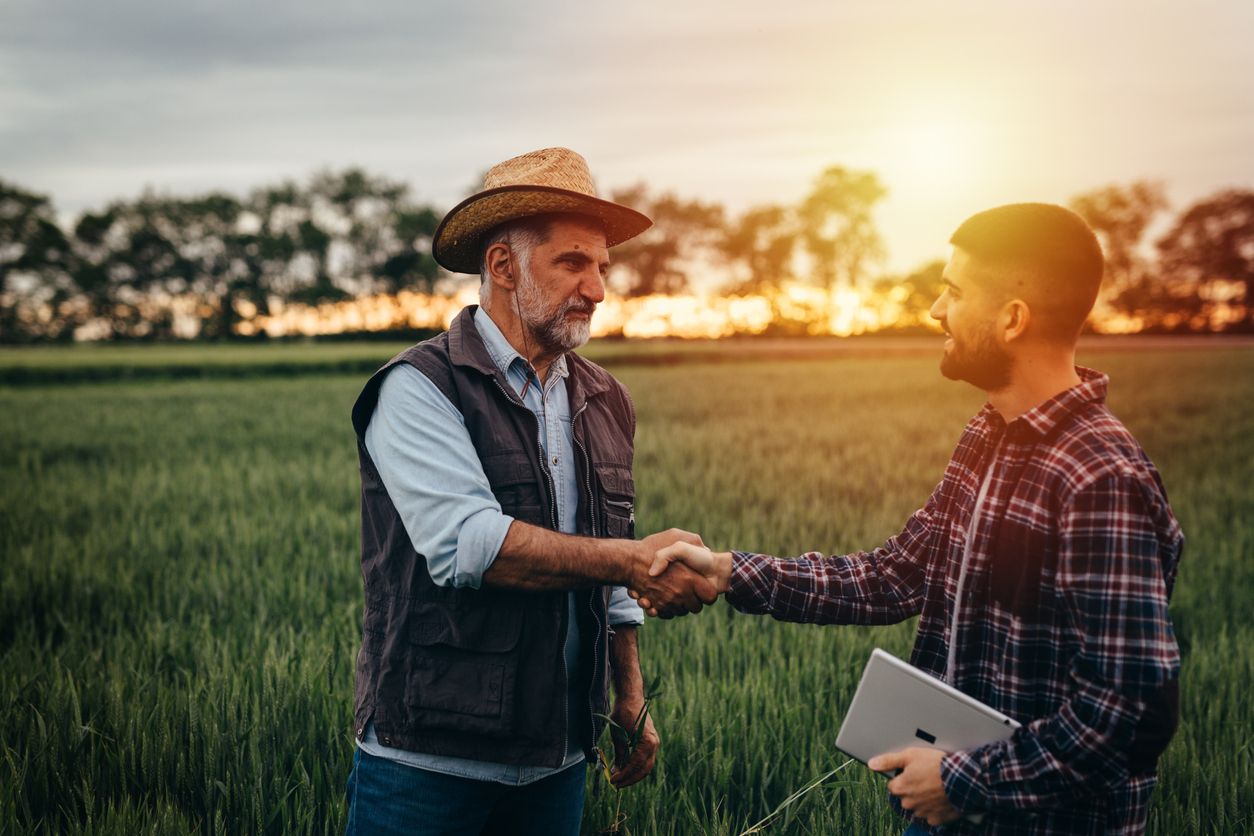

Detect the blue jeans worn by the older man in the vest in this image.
[345,750,584,836]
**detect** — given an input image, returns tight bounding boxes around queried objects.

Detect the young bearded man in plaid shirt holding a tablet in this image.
[632,203,1183,835]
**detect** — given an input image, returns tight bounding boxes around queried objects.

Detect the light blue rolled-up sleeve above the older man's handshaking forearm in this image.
[365,363,513,588]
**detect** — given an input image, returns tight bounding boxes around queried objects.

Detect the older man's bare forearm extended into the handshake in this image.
[483,520,652,592]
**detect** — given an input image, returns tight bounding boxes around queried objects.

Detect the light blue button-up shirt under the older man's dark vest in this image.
[360,308,645,785]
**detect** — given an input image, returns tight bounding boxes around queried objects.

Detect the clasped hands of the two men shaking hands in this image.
[626,529,731,618]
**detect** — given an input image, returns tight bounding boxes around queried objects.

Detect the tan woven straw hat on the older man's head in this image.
[431,148,653,273]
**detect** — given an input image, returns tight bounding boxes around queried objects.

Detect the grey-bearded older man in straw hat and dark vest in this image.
[347,148,715,835]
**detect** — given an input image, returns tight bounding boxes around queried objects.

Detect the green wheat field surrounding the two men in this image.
[0,346,1254,836]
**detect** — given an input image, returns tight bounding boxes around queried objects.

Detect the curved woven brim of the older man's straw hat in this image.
[431,185,653,273]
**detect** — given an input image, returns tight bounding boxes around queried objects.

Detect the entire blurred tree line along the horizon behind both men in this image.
[0,167,1254,343]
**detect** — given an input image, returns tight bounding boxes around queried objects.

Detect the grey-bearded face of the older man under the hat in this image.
[517,219,609,353]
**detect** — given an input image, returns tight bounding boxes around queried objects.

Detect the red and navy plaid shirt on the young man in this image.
[727,367,1184,835]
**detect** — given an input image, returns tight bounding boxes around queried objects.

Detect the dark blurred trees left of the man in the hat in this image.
[0,169,440,342]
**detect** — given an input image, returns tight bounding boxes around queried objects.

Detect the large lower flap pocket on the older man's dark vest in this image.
[405,604,523,737]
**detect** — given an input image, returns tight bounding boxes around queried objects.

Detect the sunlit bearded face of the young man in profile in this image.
[930,247,1014,392]
